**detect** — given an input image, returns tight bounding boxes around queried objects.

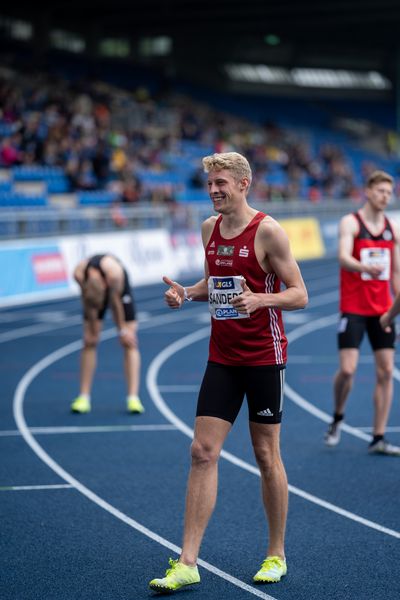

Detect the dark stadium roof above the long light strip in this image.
[0,0,400,95]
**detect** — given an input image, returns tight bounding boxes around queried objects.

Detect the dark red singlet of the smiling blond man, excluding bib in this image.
[206,212,287,366]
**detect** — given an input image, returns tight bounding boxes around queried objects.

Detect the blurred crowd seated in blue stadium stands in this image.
[0,71,400,204]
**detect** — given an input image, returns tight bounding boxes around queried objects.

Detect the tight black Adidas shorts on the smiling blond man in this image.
[196,361,285,424]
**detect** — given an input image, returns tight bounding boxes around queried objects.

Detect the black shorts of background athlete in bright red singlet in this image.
[338,313,396,351]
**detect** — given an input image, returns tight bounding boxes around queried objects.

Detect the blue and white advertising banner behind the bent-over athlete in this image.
[0,229,180,306]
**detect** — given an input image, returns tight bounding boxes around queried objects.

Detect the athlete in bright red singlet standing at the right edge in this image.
[325,171,400,456]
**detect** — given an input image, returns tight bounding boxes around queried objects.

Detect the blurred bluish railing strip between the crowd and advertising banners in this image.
[0,200,400,240]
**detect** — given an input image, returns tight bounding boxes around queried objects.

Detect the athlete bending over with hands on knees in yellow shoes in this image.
[71,254,144,413]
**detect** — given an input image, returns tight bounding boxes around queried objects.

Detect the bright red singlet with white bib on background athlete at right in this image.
[340,213,395,317]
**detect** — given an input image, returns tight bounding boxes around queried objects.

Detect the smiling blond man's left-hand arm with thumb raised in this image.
[163,217,216,308]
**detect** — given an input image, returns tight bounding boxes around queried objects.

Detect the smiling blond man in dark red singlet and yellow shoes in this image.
[150,152,307,592]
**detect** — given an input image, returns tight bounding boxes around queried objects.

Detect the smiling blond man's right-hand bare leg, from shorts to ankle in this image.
[250,421,288,558]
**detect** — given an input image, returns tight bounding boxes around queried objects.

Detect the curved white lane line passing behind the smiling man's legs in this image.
[146,328,400,539]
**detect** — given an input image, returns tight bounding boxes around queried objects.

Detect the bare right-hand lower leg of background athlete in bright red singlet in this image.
[374,348,394,435]
